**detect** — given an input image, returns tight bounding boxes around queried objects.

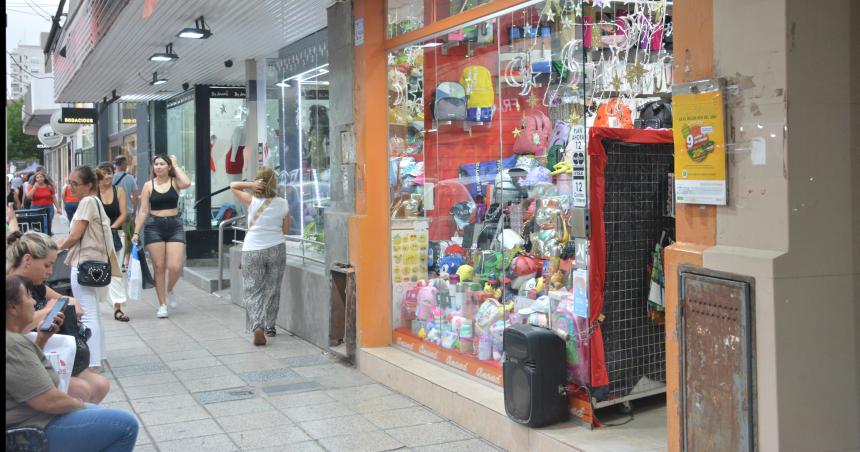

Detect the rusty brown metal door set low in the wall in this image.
[679,266,756,452]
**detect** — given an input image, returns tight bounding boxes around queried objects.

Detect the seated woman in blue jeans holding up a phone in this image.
[6,275,138,452]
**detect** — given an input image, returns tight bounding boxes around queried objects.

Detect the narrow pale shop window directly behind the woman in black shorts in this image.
[167,96,197,227]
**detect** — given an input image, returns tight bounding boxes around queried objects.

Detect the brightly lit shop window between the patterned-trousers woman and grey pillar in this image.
[261,30,331,259]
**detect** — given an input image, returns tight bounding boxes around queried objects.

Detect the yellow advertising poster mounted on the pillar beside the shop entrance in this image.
[672,90,726,206]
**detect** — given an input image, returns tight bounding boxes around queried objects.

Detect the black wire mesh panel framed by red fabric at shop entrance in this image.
[603,140,675,401]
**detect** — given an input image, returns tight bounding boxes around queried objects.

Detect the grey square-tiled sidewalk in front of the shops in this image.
[96,281,498,452]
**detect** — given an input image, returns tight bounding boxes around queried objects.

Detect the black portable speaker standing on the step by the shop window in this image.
[503,325,569,427]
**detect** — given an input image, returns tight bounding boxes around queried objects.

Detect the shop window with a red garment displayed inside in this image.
[209,98,248,227]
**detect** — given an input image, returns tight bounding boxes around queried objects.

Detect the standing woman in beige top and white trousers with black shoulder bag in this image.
[57,166,122,367]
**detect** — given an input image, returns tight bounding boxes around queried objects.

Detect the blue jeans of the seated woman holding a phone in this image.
[45,403,138,452]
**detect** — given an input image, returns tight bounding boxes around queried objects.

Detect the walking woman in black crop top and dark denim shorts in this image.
[131,155,191,319]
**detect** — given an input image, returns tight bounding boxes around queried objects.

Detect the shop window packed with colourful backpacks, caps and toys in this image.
[387,1,674,424]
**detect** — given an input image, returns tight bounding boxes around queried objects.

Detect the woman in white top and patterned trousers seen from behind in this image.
[230,167,290,345]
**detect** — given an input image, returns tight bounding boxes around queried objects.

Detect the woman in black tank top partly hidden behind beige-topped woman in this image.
[96,162,129,322]
